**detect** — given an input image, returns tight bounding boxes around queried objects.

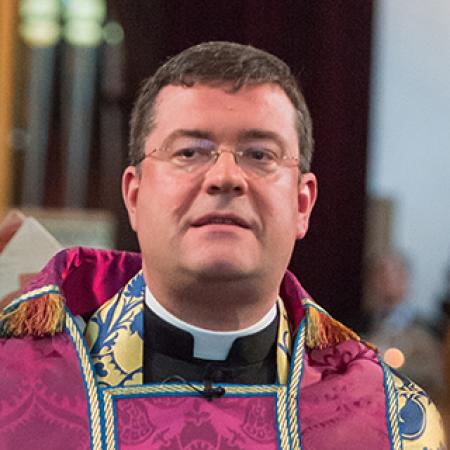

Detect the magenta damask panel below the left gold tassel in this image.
[0,334,90,450]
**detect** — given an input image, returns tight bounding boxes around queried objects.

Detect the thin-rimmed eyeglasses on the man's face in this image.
[134,139,299,176]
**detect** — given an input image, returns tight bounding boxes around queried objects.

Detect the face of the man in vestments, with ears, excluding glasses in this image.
[123,84,316,283]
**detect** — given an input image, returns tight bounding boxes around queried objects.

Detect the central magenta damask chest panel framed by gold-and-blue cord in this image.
[116,396,277,450]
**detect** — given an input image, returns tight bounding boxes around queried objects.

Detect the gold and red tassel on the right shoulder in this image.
[306,306,361,349]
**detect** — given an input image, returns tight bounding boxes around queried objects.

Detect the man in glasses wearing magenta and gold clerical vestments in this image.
[2,42,444,450]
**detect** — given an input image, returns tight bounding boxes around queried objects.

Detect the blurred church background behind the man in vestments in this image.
[0,0,450,414]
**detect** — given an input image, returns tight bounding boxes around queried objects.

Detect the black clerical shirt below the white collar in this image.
[144,305,278,384]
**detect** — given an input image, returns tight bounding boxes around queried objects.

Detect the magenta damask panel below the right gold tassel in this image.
[299,341,391,450]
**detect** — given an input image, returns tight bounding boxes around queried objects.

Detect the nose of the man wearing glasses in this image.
[204,150,247,196]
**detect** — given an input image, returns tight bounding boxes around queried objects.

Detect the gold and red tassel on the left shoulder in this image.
[0,293,65,337]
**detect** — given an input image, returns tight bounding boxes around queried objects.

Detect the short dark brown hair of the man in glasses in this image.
[129,42,314,172]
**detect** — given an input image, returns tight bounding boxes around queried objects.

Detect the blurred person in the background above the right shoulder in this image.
[365,251,445,400]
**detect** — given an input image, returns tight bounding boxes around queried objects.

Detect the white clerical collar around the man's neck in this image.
[145,287,277,361]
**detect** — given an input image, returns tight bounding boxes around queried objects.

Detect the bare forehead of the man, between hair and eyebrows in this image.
[149,83,298,144]
